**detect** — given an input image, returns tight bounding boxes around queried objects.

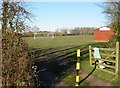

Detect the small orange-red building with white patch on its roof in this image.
[94,27,114,41]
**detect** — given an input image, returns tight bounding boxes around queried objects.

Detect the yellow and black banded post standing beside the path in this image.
[75,49,80,86]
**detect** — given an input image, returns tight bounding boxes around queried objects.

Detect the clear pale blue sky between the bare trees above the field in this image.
[28,2,106,31]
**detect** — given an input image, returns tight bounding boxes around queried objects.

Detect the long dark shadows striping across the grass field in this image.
[33,43,106,86]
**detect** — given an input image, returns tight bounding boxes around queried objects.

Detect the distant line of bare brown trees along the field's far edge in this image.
[22,27,96,37]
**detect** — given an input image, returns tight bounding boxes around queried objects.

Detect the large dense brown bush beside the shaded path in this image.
[2,33,33,86]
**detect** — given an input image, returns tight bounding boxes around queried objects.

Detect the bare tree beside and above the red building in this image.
[102,0,120,42]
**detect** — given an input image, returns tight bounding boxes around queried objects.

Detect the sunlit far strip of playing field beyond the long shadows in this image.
[25,35,94,49]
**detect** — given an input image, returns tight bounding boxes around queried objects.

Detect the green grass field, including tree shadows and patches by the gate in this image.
[24,36,118,86]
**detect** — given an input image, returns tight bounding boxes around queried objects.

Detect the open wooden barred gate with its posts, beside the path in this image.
[89,42,119,76]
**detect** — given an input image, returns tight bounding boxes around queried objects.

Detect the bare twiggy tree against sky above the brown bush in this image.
[2,0,30,33]
